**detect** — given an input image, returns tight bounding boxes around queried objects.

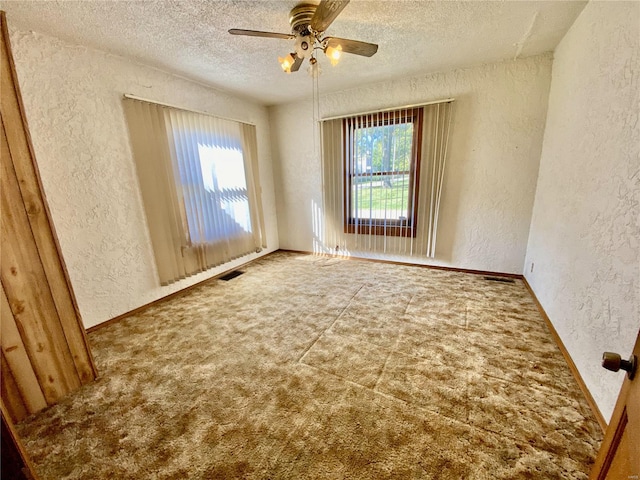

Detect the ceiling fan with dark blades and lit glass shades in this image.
[229,0,378,73]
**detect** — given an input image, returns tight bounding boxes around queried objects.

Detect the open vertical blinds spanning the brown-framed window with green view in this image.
[321,100,453,257]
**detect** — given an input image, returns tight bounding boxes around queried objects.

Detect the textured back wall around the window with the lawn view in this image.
[270,55,551,273]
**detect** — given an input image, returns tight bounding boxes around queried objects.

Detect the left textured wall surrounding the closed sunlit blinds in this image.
[6,31,278,327]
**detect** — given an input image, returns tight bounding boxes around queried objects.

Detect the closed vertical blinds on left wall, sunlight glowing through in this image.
[124,98,265,285]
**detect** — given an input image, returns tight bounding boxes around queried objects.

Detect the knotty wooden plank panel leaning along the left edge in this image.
[0,12,96,420]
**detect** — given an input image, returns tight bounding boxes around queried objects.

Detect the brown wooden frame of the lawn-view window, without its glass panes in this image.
[342,107,423,238]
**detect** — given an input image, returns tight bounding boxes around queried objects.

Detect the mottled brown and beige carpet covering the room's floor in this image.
[18,252,601,480]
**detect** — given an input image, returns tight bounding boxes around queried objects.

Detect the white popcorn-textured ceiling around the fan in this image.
[0,0,586,105]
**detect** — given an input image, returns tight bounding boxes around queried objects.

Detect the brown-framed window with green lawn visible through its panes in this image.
[343,108,422,237]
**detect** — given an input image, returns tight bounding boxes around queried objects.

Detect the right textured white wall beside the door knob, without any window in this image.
[525,2,640,419]
